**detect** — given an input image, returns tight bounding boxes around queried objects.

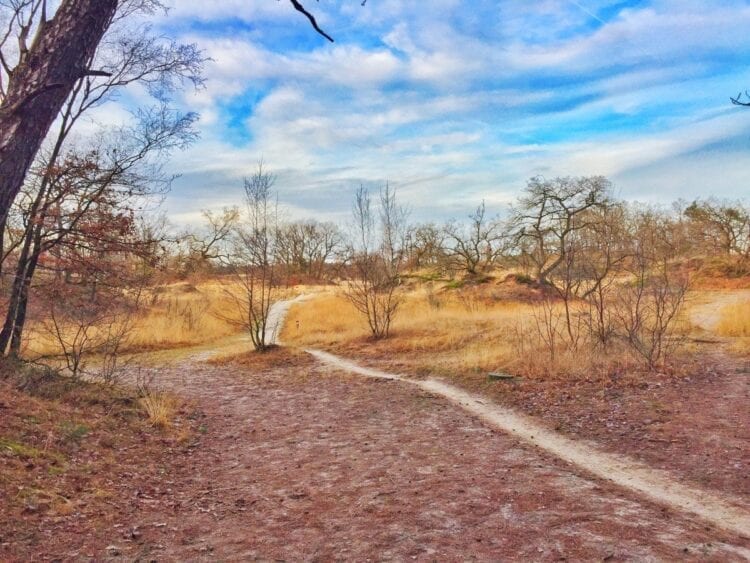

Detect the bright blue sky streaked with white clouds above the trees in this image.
[148,0,750,223]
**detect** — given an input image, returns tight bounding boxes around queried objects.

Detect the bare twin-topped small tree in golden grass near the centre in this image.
[346,184,407,339]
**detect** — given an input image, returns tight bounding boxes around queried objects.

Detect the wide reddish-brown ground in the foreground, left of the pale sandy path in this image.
[5,351,750,561]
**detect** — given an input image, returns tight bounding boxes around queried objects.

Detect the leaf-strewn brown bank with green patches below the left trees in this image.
[0,368,203,561]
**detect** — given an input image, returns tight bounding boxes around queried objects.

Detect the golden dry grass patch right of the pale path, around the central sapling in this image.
[282,288,633,384]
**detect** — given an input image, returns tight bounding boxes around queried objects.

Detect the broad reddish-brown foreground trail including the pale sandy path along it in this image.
[85,297,750,561]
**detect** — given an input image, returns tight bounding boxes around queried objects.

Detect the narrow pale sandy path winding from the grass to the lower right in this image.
[258,296,750,540]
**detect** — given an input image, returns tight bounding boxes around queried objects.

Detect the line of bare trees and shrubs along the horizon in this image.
[175,172,750,365]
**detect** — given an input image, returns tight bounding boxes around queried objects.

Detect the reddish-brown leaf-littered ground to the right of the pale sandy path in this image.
[346,344,750,509]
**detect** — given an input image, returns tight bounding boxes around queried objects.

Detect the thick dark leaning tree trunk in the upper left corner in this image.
[0,0,117,227]
